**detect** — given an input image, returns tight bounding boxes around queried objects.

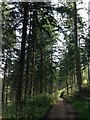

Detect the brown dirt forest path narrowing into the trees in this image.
[43,99,76,120]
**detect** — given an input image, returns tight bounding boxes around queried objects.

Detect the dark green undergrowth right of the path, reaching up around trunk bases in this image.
[65,87,90,120]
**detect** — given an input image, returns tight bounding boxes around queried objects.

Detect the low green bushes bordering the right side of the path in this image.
[66,95,90,120]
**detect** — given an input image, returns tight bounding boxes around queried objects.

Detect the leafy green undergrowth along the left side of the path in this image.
[3,93,57,119]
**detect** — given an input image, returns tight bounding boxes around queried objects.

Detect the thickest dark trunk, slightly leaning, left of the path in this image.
[16,2,28,105]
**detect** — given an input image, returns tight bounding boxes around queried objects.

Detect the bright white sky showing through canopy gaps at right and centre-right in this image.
[52,0,89,62]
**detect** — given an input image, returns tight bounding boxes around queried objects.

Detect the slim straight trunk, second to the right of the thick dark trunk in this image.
[30,3,37,96]
